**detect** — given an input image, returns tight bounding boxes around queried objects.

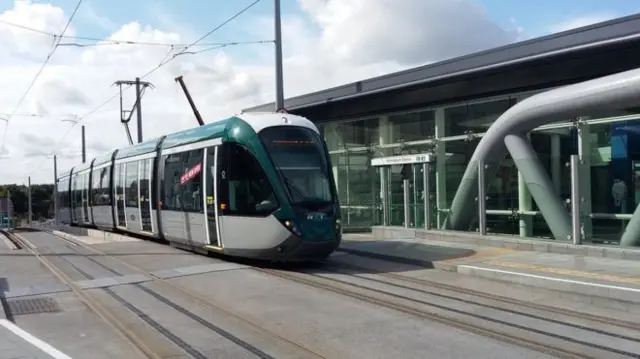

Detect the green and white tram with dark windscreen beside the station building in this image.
[57,113,342,261]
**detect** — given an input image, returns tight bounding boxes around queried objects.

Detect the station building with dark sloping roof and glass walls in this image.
[244,15,640,243]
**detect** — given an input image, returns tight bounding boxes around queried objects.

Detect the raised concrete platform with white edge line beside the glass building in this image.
[339,234,640,304]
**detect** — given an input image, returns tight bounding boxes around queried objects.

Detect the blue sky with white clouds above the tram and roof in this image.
[0,0,640,184]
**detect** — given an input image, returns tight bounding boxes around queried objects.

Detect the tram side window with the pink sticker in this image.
[161,149,204,213]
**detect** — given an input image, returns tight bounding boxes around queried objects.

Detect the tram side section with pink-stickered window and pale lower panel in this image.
[158,148,207,247]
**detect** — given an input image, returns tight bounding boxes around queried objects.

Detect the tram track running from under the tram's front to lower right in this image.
[256,268,640,359]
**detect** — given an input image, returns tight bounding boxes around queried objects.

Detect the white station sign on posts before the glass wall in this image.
[371,153,436,229]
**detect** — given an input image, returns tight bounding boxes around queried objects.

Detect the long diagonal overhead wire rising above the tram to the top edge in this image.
[25,0,264,179]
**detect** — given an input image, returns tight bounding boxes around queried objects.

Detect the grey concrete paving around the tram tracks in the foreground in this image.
[0,232,640,358]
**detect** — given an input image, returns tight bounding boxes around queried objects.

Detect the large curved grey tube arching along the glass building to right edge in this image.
[443,69,640,246]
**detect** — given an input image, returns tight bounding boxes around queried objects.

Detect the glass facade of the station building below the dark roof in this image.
[320,93,640,243]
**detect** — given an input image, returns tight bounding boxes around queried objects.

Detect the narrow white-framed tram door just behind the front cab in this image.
[208,146,226,248]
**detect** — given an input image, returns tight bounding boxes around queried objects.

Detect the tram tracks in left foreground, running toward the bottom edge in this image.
[10,230,324,359]
